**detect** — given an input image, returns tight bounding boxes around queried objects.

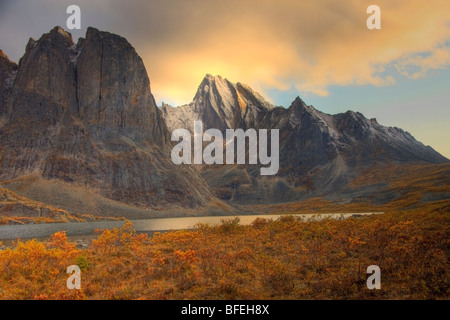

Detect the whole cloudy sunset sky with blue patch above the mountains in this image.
[0,0,450,158]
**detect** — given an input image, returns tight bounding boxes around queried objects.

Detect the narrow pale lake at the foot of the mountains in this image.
[0,212,380,240]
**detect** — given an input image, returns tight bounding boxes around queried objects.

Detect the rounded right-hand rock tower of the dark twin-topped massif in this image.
[77,28,167,144]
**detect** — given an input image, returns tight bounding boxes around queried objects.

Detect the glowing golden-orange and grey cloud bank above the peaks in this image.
[0,0,450,104]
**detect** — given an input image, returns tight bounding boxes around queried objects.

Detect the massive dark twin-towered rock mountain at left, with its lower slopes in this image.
[0,27,215,215]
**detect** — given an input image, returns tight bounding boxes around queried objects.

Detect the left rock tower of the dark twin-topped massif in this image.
[0,28,76,179]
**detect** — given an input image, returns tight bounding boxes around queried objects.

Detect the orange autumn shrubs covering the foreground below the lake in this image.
[0,207,450,299]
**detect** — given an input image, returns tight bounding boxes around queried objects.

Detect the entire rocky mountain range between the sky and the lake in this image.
[0,27,448,221]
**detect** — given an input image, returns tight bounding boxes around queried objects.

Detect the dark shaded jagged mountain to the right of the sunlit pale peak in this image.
[192,84,448,204]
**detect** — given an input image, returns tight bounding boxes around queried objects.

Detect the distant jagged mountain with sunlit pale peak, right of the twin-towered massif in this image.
[161,75,448,204]
